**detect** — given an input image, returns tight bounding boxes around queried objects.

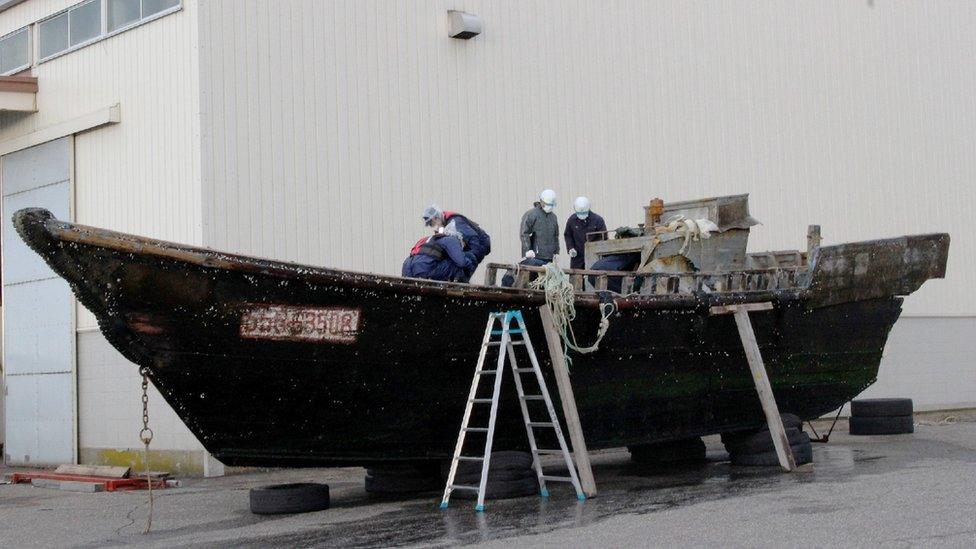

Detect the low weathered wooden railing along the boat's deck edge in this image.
[485,263,809,295]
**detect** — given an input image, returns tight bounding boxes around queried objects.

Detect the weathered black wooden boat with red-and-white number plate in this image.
[14,196,949,467]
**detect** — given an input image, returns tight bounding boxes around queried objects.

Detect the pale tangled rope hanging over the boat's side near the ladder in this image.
[529,263,617,362]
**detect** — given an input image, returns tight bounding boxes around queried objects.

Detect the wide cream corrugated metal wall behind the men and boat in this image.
[200,0,976,315]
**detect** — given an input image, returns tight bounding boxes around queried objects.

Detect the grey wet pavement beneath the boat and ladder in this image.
[0,421,976,547]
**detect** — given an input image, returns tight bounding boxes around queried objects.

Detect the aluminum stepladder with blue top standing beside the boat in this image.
[441,311,586,511]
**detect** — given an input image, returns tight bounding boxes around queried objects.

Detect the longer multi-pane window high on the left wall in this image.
[37,0,181,61]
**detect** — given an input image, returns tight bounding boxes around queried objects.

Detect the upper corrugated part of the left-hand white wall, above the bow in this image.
[0,0,202,329]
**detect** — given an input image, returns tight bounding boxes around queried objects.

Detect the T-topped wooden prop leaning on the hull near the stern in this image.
[710,302,796,471]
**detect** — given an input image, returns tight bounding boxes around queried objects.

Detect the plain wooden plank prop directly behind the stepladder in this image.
[539,305,596,498]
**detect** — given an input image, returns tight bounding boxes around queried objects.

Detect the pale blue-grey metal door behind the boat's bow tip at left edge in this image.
[0,137,77,465]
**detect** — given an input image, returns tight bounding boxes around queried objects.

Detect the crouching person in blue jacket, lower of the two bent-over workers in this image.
[401,227,476,282]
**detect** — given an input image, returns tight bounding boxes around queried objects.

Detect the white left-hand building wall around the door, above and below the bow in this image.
[0,0,202,462]
